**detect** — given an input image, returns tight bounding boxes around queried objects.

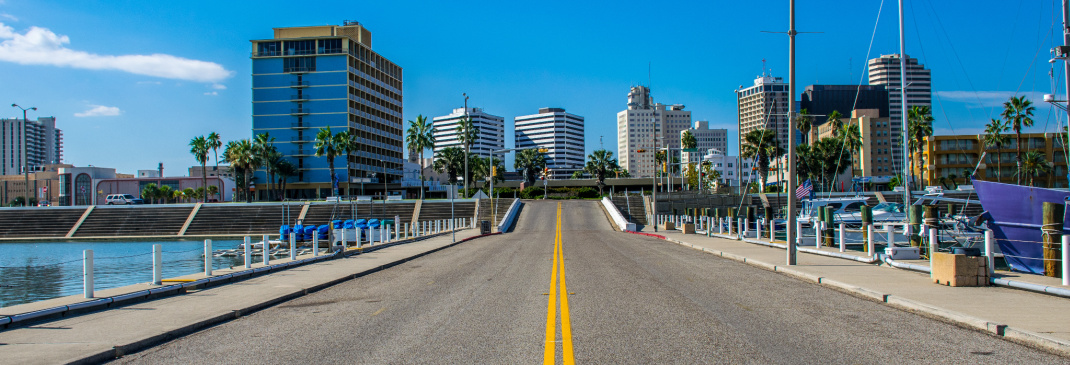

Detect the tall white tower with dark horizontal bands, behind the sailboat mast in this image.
[869,54,933,161]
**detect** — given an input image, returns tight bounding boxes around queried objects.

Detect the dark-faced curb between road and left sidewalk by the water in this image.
[59,232,502,364]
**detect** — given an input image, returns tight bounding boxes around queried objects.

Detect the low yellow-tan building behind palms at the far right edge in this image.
[915,133,1067,188]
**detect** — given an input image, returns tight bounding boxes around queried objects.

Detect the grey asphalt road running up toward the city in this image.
[118,201,1067,364]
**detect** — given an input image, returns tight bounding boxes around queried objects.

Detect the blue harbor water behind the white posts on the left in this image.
[0,240,248,307]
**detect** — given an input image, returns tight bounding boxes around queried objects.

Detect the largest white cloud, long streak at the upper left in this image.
[0,22,234,82]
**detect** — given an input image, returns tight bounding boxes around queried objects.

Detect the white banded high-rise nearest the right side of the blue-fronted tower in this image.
[431,108,505,157]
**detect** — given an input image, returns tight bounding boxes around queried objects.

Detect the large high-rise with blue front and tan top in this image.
[251,21,403,199]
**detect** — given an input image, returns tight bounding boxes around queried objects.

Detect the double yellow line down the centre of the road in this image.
[542,202,576,365]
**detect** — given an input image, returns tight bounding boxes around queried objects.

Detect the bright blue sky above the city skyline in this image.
[0,0,1066,174]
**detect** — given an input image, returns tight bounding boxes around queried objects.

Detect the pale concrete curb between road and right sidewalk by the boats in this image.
[628,231,1070,356]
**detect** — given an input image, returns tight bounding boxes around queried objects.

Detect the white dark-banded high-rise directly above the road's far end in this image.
[514,108,586,179]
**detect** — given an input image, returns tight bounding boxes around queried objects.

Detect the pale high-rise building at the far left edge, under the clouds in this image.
[0,117,63,174]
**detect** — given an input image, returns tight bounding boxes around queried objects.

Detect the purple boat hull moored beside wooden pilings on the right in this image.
[974,180,1070,275]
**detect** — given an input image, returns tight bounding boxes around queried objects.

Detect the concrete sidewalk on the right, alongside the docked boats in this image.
[642,230,1070,355]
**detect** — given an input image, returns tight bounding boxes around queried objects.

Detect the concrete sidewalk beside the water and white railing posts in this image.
[0,229,479,364]
